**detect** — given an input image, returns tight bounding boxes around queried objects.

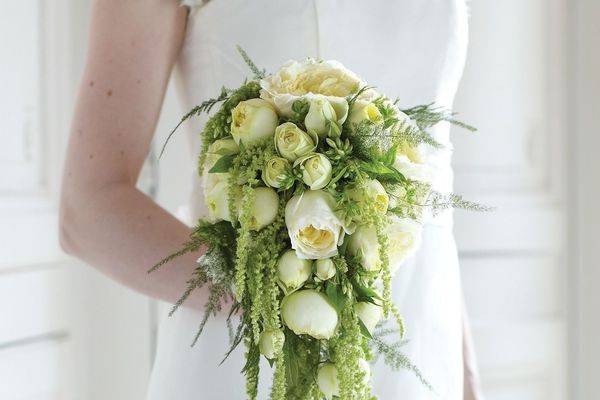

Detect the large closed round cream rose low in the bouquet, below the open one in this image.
[281,289,338,339]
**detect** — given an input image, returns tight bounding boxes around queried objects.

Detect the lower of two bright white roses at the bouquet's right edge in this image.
[386,216,423,273]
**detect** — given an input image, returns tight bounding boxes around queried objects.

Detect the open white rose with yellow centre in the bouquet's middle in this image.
[285,190,344,259]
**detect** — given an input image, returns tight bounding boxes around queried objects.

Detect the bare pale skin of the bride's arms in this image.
[60,0,481,400]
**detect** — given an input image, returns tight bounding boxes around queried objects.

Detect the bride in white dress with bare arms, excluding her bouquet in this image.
[60,0,481,400]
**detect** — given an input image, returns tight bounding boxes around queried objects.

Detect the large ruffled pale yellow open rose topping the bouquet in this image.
[260,59,360,116]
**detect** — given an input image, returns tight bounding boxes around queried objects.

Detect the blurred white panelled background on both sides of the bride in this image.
[0,0,600,400]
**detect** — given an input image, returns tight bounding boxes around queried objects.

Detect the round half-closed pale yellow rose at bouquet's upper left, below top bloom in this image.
[231,99,278,145]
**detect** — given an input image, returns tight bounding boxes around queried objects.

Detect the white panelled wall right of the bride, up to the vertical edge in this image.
[453,0,568,400]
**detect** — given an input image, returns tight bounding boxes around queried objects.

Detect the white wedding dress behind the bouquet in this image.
[148,0,467,400]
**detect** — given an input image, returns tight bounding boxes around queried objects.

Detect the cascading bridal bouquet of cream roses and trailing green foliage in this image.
[152,49,485,400]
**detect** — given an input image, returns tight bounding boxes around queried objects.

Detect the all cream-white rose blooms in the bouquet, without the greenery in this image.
[204,59,428,398]
